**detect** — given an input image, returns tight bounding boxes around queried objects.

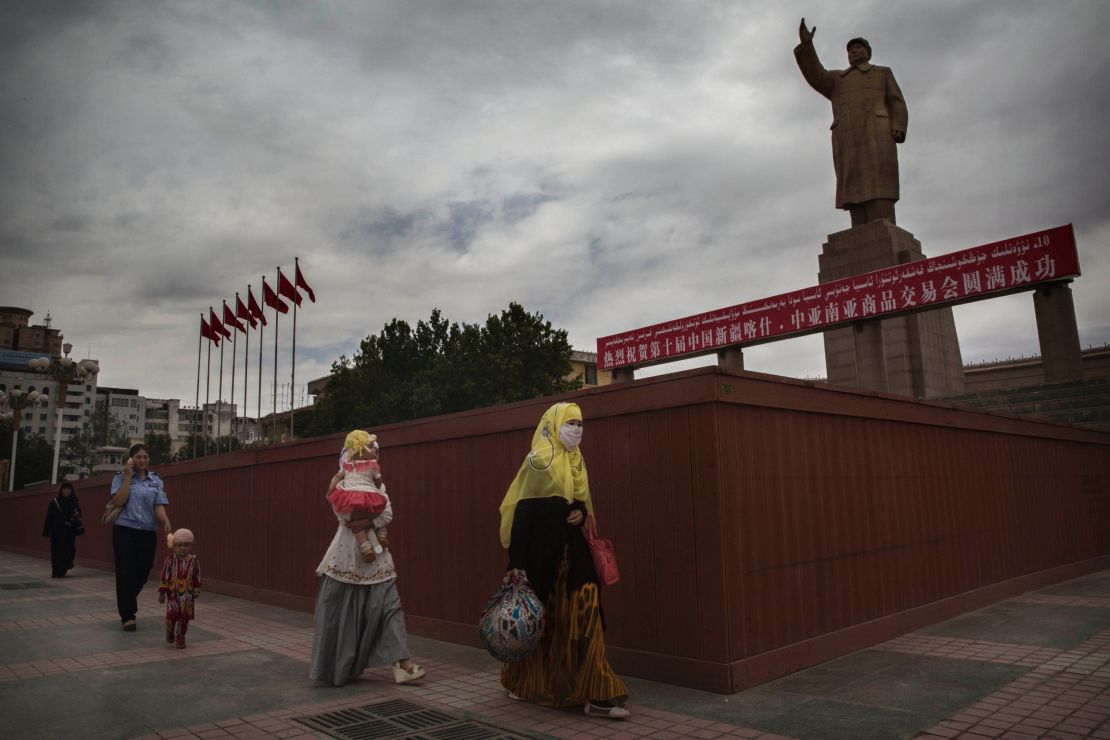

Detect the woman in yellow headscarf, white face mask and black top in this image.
[501,403,628,719]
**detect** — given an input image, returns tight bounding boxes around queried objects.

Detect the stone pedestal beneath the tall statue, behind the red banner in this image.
[818,220,963,398]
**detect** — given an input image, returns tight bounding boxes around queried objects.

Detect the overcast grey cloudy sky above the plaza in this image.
[0,0,1110,413]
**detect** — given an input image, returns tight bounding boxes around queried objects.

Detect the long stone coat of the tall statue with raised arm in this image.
[794,43,909,209]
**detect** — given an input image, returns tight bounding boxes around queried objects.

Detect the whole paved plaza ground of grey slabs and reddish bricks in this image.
[0,551,1110,740]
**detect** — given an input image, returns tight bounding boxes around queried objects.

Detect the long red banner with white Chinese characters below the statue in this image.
[597,224,1079,369]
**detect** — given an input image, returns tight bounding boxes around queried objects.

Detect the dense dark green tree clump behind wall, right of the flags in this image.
[302,303,582,435]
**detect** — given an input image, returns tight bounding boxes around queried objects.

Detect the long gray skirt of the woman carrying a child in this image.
[309,576,410,686]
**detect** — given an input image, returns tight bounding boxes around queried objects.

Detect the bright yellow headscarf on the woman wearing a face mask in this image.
[501,403,594,549]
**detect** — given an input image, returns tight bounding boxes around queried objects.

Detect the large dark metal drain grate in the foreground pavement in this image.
[295,699,529,740]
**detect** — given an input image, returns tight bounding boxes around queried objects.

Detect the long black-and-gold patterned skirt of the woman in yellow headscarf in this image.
[501,558,628,707]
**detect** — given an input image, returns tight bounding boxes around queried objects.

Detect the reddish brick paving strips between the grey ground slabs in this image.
[0,551,1110,740]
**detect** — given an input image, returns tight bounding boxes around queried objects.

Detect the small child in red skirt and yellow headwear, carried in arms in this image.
[327,429,390,562]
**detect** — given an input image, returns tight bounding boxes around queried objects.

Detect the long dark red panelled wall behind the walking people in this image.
[0,368,1110,692]
